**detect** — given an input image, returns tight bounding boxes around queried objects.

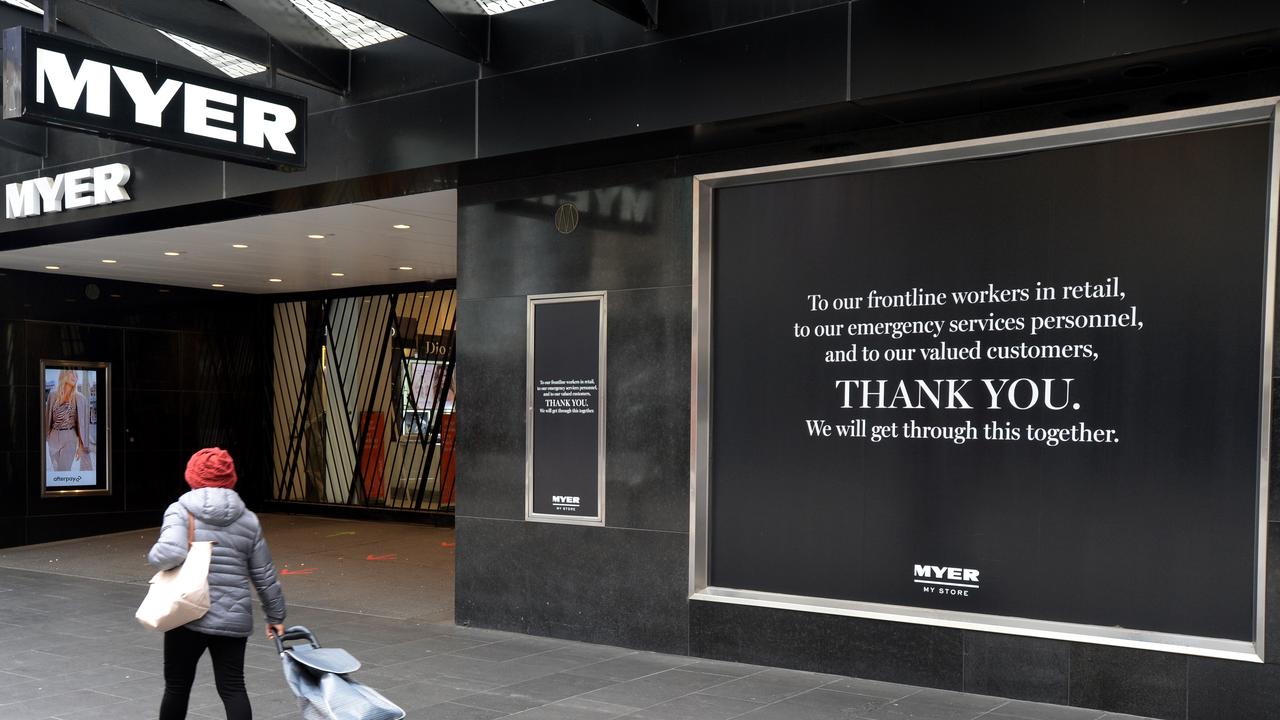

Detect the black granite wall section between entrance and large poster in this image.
[456,170,692,652]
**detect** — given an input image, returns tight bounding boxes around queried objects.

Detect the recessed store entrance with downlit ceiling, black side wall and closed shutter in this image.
[0,191,461,545]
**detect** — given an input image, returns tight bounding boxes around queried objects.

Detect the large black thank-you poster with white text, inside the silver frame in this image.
[709,124,1270,641]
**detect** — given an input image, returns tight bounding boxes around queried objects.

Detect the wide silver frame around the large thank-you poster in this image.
[689,97,1280,662]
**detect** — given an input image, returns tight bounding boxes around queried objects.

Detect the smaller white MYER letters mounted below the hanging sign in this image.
[4,163,129,219]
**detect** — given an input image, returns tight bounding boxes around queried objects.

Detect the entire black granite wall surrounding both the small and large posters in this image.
[456,156,1280,720]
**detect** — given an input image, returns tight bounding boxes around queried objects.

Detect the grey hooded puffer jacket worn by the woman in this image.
[147,488,284,638]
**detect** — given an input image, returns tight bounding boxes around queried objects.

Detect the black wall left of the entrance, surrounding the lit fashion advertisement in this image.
[0,272,270,547]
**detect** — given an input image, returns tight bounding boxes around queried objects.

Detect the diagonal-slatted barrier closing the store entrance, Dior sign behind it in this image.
[271,286,457,514]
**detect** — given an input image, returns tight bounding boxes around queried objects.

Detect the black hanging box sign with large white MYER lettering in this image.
[4,27,307,168]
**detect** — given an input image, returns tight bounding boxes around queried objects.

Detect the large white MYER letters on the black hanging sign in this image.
[35,47,298,155]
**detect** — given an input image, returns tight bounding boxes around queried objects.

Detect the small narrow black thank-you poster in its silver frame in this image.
[525,292,605,525]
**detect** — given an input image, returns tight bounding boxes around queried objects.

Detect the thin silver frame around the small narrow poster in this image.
[525,291,609,527]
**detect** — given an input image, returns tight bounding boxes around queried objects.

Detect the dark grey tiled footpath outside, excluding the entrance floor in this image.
[0,569,1152,720]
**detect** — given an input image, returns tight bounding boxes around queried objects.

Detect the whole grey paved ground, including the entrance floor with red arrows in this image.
[0,516,1162,720]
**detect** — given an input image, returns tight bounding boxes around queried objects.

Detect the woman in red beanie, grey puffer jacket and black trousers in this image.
[147,447,284,720]
